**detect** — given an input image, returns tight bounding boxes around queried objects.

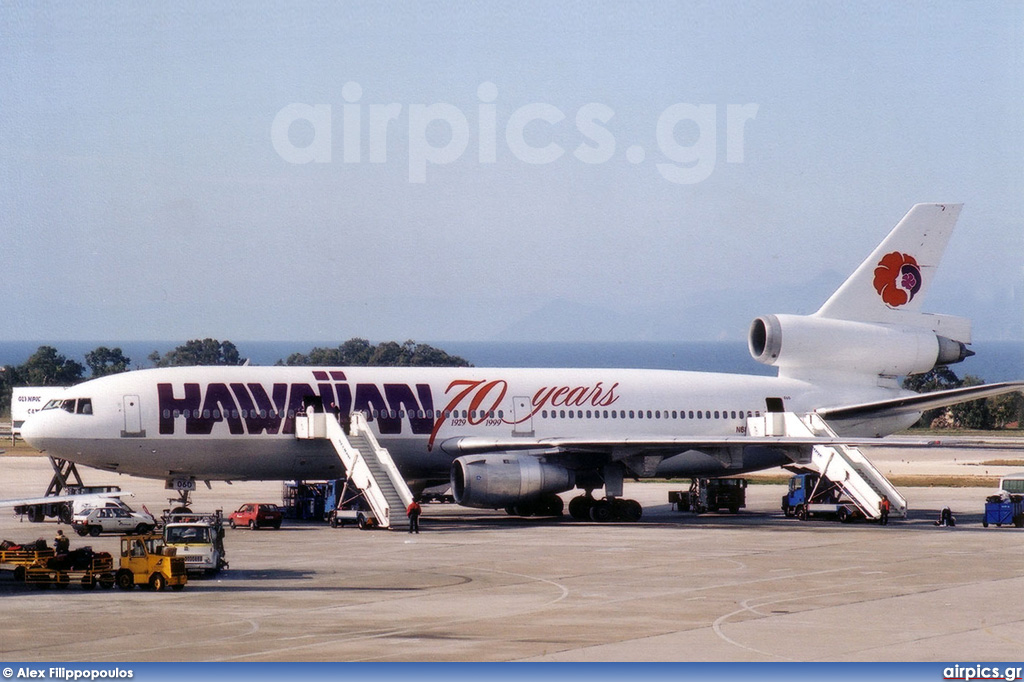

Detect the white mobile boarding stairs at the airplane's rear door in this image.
[746,412,907,519]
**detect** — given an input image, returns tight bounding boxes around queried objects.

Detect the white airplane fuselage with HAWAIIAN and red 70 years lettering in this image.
[24,360,913,483]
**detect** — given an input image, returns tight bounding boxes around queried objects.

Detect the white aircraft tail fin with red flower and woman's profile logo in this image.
[815,204,970,342]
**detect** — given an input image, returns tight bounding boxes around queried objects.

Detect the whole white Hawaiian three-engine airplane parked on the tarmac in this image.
[23,204,1024,518]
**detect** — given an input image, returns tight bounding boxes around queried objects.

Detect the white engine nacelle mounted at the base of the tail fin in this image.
[748,315,974,376]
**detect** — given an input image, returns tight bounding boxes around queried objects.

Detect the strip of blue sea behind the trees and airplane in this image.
[0,339,1024,382]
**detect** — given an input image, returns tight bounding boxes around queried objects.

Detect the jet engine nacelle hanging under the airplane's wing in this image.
[452,455,575,509]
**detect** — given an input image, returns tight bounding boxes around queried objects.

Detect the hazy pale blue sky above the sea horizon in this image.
[0,2,1024,341]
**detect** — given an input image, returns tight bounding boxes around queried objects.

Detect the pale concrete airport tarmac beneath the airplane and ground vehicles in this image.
[0,442,1024,664]
